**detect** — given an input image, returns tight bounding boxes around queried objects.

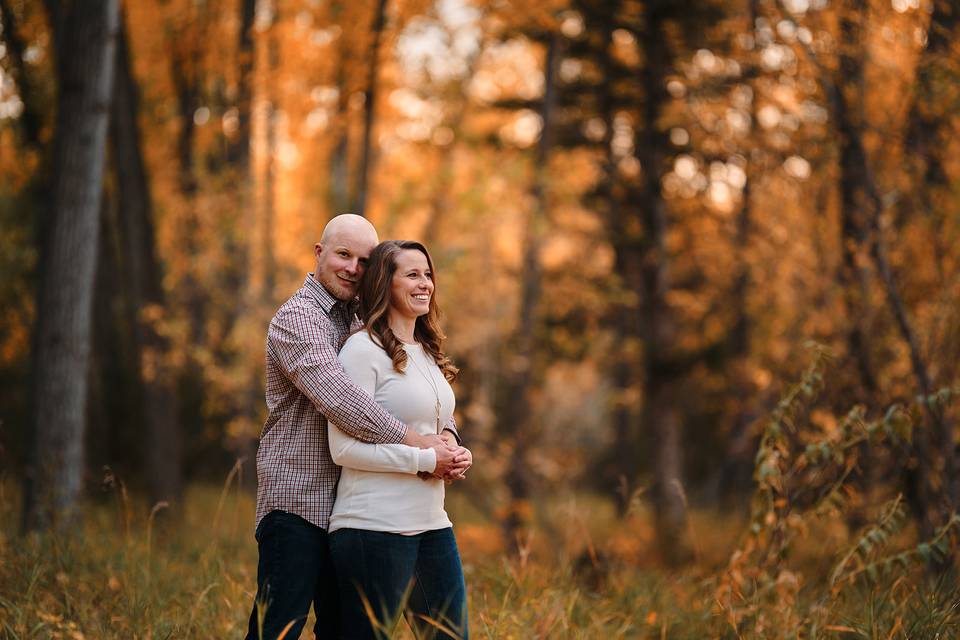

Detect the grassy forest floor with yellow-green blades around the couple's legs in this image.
[0,468,960,640]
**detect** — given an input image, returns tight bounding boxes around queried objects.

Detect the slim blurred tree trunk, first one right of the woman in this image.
[502,33,560,550]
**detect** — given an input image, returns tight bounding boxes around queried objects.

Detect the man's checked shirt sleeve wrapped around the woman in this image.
[267,306,407,443]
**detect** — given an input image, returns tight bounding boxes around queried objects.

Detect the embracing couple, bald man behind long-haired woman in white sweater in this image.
[247,214,473,640]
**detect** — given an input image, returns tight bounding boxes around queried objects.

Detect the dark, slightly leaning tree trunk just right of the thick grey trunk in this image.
[110,12,183,502]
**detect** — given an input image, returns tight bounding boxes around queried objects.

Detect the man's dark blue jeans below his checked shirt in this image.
[247,511,340,640]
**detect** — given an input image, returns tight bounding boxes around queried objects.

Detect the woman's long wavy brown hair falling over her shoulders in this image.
[360,240,459,382]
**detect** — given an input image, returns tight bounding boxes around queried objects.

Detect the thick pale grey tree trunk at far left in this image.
[24,0,119,528]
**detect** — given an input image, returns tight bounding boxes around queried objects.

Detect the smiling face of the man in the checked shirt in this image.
[314,229,377,302]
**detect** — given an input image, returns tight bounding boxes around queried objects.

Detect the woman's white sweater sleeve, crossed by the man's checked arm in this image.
[327,341,437,473]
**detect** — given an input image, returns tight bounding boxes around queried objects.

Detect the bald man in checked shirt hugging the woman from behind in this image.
[247,214,470,640]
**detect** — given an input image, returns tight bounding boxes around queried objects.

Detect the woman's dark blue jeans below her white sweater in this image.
[330,527,467,640]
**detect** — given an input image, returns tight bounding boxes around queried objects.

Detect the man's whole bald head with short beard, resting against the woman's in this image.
[313,213,378,300]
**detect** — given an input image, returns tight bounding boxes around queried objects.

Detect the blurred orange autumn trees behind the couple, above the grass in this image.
[0,0,960,560]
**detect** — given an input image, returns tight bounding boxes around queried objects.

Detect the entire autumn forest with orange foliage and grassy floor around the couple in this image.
[0,0,960,638]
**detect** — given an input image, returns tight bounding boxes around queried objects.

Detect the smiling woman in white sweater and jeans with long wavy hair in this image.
[328,240,472,639]
